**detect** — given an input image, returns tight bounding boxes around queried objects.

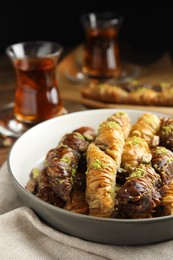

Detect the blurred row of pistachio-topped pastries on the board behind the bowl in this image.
[81,80,173,106]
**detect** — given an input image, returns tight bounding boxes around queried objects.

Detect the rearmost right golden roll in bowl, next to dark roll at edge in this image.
[129,113,160,147]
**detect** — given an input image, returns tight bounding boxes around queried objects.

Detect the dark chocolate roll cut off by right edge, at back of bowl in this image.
[160,118,173,151]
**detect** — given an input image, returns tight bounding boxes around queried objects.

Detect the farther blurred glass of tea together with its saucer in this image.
[66,12,139,85]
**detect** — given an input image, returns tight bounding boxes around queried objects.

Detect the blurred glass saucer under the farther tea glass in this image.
[65,63,140,85]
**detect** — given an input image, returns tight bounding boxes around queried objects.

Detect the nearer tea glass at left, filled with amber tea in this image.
[6,41,63,124]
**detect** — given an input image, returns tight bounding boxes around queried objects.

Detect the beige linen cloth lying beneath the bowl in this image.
[0,163,173,260]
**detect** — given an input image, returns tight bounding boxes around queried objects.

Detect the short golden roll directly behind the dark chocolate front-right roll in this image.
[121,136,152,173]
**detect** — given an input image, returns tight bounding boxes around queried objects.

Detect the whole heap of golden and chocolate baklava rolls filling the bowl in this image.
[26,112,173,218]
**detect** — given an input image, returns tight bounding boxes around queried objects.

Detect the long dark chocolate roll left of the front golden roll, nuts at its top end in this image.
[46,127,94,202]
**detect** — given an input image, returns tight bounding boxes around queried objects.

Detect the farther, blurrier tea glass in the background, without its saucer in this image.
[81,12,123,79]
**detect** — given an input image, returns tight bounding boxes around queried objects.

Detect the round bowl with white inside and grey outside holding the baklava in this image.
[8,109,173,245]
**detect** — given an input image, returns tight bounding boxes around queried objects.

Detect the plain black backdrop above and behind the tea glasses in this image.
[0,0,173,63]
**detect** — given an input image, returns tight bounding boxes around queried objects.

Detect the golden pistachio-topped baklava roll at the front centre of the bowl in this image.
[86,143,117,218]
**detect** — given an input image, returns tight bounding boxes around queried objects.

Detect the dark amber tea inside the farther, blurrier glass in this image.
[83,28,121,78]
